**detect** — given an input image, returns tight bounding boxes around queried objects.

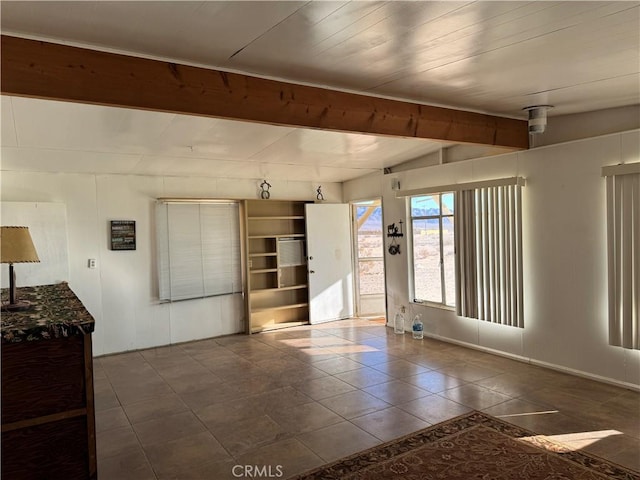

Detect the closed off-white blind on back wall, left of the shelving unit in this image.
[156,202,242,301]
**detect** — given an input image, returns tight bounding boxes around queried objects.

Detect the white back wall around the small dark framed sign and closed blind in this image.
[1,171,342,355]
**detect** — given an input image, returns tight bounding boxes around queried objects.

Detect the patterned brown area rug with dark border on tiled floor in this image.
[294,412,640,480]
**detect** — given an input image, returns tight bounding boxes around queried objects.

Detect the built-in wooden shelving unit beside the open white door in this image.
[245,200,309,333]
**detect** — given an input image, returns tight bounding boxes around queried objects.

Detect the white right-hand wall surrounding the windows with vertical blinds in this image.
[344,130,640,386]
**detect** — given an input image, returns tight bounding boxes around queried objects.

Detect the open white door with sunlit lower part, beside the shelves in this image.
[305,203,353,324]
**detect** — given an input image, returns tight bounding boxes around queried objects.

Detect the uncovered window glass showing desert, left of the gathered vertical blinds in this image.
[411,193,455,306]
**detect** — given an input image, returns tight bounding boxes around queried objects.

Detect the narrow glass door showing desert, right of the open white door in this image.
[351,199,385,317]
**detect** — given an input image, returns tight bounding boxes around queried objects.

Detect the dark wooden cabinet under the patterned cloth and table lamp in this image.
[1,287,97,480]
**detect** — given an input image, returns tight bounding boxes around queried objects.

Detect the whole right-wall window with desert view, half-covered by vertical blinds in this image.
[404,177,525,327]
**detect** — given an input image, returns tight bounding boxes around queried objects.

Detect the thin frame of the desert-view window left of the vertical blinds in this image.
[407,190,456,311]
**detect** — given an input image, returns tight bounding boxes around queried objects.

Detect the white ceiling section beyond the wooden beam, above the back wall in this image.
[1,96,450,182]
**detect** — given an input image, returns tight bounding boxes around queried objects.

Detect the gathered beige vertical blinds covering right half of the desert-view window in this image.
[455,180,524,328]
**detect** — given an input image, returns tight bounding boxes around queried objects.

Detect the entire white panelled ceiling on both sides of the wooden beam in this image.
[1,1,640,181]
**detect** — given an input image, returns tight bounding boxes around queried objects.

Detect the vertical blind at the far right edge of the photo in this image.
[603,163,640,350]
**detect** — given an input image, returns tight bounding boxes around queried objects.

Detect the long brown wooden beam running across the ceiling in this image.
[0,35,529,149]
